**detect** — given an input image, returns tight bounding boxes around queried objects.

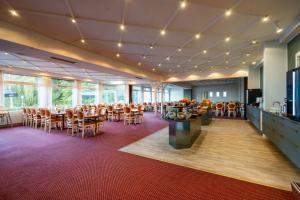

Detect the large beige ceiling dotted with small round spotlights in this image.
[0,0,300,80]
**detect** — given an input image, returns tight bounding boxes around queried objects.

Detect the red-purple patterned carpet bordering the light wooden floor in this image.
[0,114,292,200]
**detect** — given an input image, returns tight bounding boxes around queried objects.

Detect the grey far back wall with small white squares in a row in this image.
[193,80,244,103]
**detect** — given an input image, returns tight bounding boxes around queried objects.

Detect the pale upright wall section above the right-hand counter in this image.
[263,41,287,109]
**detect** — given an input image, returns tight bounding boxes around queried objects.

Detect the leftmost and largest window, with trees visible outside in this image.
[3,74,38,109]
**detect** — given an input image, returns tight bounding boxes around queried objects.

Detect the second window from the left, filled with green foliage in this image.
[52,79,74,107]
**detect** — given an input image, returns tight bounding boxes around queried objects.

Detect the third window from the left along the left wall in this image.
[81,82,98,105]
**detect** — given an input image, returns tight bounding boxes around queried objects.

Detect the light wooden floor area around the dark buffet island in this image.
[120,119,300,190]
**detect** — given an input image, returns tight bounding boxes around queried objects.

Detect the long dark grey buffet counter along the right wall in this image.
[247,106,300,168]
